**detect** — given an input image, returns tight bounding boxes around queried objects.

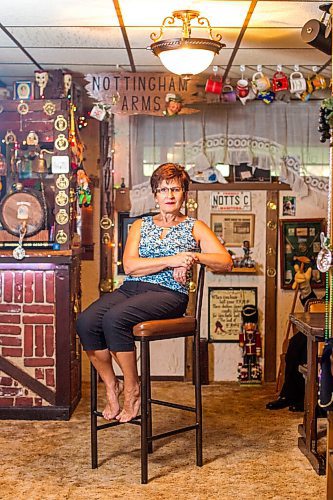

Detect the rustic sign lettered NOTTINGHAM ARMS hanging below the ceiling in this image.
[85,72,205,115]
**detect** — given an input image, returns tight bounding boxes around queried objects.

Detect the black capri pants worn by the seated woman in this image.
[76,281,188,352]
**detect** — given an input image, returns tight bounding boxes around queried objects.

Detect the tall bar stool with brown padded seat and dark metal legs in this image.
[90,265,205,484]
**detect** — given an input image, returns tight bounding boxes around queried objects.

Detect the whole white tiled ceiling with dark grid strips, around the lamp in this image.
[0,0,331,84]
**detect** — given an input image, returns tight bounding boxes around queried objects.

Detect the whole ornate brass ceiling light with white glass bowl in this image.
[148,10,225,78]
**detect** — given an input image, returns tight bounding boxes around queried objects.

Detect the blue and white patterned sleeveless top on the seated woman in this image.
[125,215,200,294]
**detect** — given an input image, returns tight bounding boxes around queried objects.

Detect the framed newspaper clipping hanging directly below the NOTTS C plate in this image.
[210,214,254,247]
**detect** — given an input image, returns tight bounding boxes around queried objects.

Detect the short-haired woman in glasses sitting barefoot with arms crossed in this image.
[77,163,232,423]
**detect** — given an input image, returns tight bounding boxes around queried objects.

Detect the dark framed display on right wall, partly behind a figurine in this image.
[280,219,325,289]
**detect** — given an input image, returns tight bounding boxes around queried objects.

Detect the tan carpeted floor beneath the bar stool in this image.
[0,382,326,500]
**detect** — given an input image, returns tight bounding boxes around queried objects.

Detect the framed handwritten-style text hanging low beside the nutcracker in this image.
[208,287,257,342]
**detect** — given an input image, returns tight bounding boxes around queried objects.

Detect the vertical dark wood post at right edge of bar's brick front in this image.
[55,266,71,406]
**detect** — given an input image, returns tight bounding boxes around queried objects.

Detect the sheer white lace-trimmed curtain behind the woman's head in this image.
[130,101,329,215]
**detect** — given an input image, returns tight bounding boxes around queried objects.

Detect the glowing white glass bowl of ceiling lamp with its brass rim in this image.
[150,38,225,76]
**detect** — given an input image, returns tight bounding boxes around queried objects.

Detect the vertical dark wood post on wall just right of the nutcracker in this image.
[264,191,279,382]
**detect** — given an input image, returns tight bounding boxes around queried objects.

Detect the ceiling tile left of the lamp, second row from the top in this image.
[8,26,125,49]
